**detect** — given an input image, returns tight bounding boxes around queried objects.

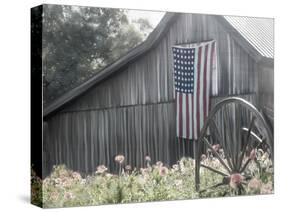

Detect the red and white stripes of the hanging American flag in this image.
[176,41,216,140]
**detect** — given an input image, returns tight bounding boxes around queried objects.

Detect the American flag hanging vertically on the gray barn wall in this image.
[173,41,217,140]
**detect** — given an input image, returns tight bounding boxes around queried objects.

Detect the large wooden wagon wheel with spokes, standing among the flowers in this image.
[195,97,273,193]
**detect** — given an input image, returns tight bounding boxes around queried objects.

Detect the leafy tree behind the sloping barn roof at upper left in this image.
[42,5,152,104]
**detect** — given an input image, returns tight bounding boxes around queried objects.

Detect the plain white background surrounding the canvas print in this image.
[0,0,276,212]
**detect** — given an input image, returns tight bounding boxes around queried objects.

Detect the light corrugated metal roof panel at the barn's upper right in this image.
[224,16,274,58]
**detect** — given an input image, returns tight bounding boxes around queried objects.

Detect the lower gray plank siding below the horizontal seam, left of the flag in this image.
[44,103,179,176]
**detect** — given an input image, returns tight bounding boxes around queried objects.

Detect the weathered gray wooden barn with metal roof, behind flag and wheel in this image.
[43,13,274,176]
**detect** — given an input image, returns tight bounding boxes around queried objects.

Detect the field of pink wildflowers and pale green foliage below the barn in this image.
[32,150,273,208]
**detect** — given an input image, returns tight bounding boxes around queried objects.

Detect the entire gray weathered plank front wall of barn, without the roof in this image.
[44,14,257,177]
